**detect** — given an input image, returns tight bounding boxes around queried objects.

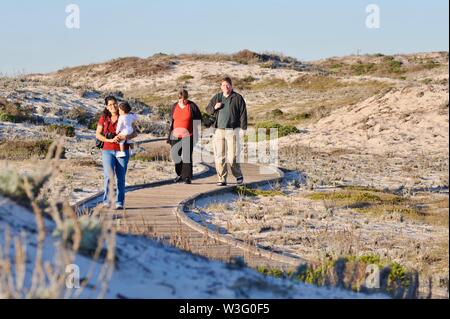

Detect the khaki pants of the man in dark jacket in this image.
[213,129,242,182]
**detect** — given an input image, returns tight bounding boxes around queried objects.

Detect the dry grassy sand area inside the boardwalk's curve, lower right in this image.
[195,180,448,297]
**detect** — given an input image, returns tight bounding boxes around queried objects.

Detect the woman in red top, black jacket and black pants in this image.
[167,89,202,184]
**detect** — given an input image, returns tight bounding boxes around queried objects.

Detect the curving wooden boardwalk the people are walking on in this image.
[89,143,302,270]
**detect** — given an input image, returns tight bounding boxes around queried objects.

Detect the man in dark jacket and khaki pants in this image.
[206,77,247,186]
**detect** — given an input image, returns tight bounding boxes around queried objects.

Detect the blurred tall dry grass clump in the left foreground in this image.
[0,140,115,299]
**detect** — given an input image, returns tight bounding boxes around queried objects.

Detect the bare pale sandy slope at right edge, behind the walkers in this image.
[282,85,449,155]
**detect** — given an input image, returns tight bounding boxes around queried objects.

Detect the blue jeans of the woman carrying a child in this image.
[102,151,130,206]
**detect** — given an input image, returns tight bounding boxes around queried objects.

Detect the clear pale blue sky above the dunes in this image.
[0,0,449,74]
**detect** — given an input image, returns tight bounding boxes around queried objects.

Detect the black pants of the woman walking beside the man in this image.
[171,136,194,180]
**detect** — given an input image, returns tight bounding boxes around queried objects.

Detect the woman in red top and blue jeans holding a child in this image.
[96,96,137,210]
